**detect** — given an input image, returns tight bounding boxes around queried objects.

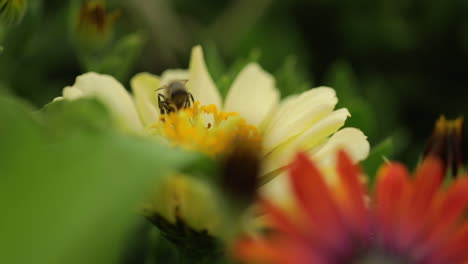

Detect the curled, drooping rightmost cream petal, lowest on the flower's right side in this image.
[309,127,370,166]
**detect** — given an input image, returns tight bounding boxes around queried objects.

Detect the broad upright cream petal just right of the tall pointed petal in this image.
[224,63,280,126]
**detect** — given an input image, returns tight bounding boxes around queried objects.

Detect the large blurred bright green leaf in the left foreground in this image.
[0,96,199,264]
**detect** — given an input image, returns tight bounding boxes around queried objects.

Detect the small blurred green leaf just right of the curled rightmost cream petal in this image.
[361,137,394,186]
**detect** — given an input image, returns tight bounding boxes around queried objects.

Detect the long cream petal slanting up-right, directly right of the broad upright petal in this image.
[263,87,338,154]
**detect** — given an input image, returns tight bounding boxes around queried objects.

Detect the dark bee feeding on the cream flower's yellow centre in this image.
[158,80,194,115]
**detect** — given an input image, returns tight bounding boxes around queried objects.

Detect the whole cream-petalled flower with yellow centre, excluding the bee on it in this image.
[54,46,369,233]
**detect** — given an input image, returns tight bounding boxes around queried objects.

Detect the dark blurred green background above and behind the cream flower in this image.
[0,0,468,164]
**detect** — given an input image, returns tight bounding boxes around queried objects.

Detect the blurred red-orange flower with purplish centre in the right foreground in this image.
[234,152,468,264]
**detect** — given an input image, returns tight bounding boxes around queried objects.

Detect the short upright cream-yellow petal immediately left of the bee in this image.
[130,72,160,126]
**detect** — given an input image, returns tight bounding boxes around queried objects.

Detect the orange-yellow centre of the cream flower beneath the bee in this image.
[149,102,261,156]
